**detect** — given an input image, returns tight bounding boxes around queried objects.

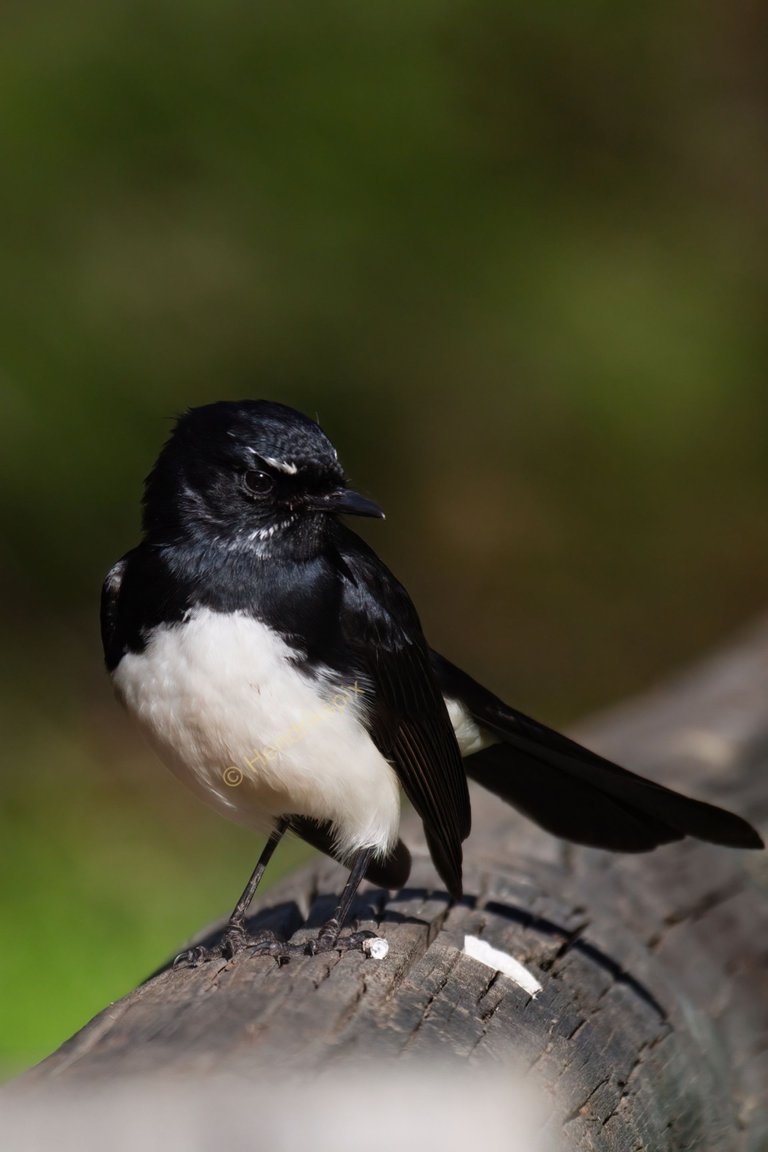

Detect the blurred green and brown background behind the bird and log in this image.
[0,0,768,1073]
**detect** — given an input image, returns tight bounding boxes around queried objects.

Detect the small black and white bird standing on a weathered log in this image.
[101,400,762,958]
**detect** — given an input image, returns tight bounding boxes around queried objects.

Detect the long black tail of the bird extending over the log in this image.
[433,653,763,852]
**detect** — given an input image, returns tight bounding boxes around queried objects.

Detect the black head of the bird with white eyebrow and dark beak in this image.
[144,400,383,552]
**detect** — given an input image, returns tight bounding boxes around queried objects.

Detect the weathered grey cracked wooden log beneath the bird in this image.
[7,623,768,1152]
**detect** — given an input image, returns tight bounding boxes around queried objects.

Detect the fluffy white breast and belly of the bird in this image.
[113,608,400,855]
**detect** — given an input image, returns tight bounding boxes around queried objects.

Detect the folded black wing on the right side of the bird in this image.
[336,524,471,899]
